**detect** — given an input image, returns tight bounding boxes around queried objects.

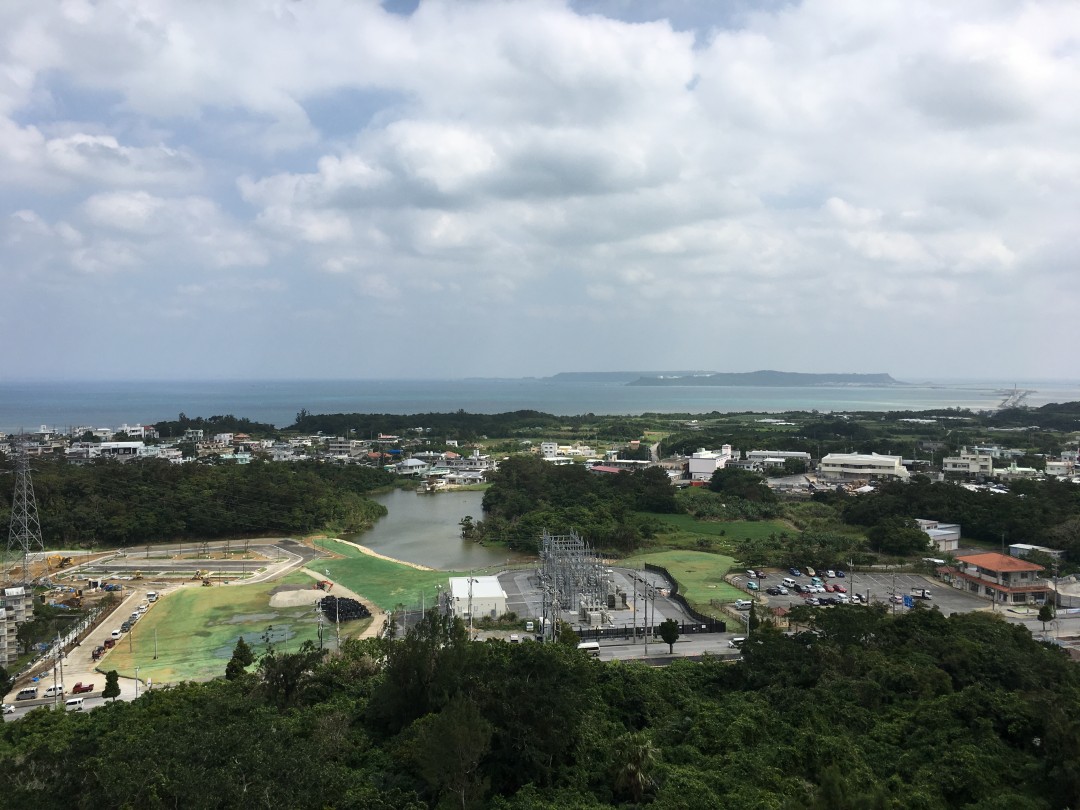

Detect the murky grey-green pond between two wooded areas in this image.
[348,489,529,571]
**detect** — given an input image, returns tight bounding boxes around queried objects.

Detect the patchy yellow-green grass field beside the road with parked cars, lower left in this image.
[102,573,372,684]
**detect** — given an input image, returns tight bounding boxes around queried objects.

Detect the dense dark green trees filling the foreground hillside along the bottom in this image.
[0,606,1080,810]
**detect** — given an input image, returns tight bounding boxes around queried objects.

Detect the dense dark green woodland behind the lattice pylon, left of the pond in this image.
[0,459,393,548]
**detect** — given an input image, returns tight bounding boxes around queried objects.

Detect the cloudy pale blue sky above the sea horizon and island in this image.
[0,0,1080,380]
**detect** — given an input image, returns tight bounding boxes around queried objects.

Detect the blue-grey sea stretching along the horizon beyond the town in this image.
[0,378,1080,433]
